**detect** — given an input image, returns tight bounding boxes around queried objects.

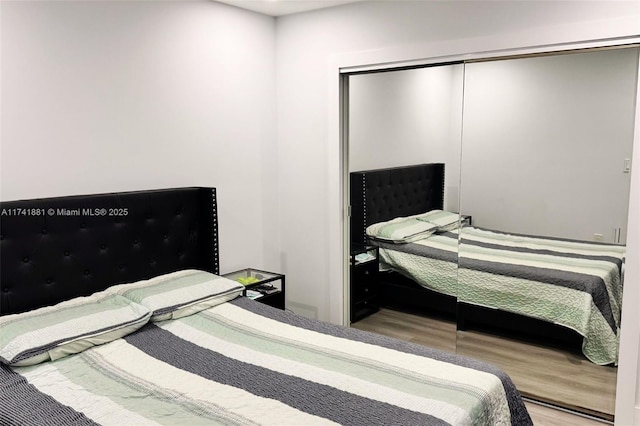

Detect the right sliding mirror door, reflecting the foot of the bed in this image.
[457,47,638,419]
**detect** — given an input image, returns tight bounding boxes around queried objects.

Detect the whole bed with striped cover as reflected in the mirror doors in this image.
[352,164,625,365]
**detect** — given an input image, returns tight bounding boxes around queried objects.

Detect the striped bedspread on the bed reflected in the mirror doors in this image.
[370,227,625,365]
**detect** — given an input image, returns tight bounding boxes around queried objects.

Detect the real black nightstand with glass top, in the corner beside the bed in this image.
[222,268,285,311]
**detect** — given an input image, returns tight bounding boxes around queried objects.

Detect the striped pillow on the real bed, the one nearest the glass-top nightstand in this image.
[107,269,244,322]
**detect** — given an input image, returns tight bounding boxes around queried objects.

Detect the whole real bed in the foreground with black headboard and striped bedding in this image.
[0,188,531,425]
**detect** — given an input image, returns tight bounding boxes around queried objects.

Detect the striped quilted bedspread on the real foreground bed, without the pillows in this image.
[0,298,531,425]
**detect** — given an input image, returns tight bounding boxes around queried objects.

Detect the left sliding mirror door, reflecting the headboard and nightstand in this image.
[348,64,463,351]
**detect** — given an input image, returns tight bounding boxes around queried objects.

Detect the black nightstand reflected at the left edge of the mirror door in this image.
[349,244,380,322]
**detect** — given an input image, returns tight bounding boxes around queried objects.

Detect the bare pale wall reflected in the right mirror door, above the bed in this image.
[460,49,638,243]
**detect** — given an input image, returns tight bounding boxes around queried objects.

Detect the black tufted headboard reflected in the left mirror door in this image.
[350,163,444,244]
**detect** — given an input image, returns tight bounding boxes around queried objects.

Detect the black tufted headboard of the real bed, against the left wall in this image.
[0,187,219,315]
